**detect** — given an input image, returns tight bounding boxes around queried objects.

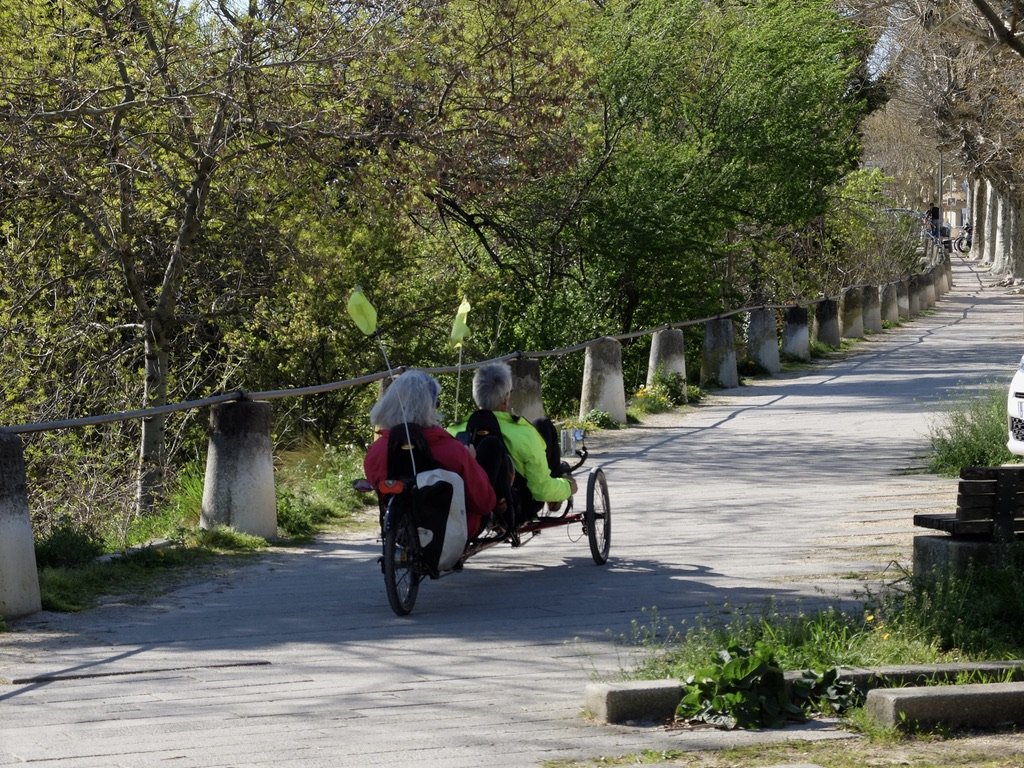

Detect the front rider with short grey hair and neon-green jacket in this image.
[449,362,577,514]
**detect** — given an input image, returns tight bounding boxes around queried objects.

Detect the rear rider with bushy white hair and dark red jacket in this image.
[362,370,497,538]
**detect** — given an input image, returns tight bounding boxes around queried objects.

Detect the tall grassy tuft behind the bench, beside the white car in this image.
[928,384,1016,475]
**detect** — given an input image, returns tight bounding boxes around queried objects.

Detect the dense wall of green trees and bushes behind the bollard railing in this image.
[0,0,905,536]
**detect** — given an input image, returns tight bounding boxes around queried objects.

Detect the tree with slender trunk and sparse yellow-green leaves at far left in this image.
[0,0,448,518]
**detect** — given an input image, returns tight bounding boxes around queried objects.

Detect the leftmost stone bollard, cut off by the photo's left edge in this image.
[0,432,42,618]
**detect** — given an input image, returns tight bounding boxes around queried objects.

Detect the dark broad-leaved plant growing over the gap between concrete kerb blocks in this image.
[676,643,804,728]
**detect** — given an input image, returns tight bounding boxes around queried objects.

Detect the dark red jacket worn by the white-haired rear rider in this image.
[362,427,498,538]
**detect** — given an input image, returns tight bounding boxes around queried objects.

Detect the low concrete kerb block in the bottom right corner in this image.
[864,683,1024,728]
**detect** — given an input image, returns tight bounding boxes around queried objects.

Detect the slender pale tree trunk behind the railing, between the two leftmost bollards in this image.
[136,317,168,515]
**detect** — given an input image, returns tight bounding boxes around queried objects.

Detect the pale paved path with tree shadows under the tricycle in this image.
[0,257,1024,768]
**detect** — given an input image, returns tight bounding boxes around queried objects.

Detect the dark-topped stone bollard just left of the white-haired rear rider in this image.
[200,400,278,540]
